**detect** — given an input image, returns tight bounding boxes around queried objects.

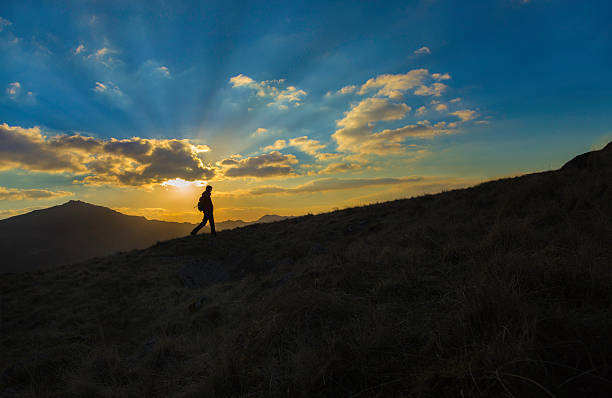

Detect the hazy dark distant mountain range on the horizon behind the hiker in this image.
[0,200,287,273]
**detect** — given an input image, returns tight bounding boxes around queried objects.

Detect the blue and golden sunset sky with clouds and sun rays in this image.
[0,0,612,222]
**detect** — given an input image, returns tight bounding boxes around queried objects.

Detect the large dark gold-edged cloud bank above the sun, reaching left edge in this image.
[0,123,215,187]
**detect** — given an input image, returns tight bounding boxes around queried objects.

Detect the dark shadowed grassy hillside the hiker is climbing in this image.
[0,144,612,397]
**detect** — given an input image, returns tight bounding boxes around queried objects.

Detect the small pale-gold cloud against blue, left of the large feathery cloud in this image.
[229,74,307,110]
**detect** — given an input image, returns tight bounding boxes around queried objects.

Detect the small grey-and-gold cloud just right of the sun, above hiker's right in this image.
[217,151,298,178]
